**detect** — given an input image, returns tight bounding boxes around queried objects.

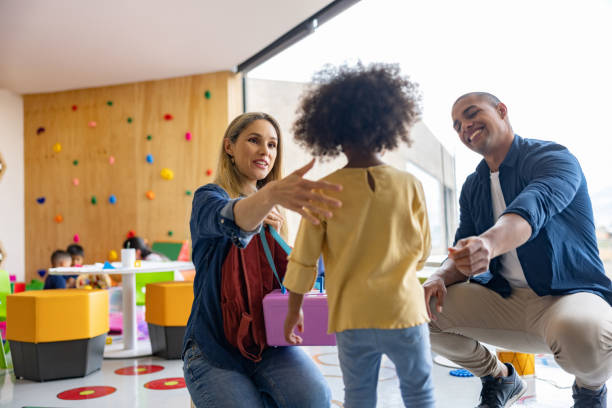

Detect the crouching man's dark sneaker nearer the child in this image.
[476,363,527,408]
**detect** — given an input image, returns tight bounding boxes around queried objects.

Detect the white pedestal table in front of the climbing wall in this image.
[49,261,195,358]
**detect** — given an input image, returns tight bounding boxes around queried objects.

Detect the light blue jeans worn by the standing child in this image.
[336,324,435,408]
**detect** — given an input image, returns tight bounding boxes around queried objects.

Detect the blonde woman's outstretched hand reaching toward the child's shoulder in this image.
[266,159,342,225]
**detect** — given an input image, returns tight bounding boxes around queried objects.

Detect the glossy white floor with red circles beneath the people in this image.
[0,347,612,408]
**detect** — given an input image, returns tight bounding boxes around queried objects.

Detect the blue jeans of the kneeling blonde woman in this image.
[183,342,331,408]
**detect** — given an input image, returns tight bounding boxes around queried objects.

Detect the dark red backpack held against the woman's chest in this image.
[221,227,287,362]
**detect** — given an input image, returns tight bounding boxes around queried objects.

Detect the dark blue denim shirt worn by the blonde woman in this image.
[183,184,259,371]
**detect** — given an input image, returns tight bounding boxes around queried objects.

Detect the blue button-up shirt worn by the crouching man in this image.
[455,135,612,304]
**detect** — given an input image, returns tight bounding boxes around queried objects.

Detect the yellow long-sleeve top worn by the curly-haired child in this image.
[284,165,431,333]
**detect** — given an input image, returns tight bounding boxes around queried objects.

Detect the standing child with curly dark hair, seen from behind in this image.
[284,64,434,408]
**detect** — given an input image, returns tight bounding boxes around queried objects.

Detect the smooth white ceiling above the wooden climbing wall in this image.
[0,0,331,94]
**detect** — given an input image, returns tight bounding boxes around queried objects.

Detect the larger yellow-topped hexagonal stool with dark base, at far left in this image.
[6,289,108,381]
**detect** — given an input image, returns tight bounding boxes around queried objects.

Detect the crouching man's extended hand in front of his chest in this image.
[448,236,494,276]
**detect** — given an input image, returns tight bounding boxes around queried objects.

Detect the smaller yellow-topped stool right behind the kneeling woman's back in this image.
[145,282,193,359]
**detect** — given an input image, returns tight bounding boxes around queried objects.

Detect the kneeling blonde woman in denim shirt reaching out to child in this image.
[183,113,341,408]
